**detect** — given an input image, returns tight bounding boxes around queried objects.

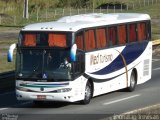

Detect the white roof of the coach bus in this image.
[22,13,150,32]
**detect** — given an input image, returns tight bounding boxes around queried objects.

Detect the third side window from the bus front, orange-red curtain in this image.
[96,28,107,48]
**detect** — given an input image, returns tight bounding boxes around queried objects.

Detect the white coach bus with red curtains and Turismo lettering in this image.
[8,13,152,104]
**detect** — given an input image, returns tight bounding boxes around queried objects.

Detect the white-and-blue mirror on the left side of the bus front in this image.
[7,43,16,62]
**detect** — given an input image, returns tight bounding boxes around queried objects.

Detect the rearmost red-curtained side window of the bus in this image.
[137,22,147,41]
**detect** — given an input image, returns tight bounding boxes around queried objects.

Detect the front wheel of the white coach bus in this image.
[81,81,92,105]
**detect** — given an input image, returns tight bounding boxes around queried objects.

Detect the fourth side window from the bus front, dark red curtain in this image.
[108,27,117,45]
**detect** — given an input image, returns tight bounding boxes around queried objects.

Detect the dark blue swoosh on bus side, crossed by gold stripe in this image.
[91,41,148,75]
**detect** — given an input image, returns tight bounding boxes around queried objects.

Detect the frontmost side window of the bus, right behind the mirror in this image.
[75,32,84,50]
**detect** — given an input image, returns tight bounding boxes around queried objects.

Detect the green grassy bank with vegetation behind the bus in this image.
[0,0,160,39]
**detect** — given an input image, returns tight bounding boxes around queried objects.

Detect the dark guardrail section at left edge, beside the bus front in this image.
[0,71,15,92]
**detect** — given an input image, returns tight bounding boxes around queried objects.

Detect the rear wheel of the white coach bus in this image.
[128,70,137,92]
